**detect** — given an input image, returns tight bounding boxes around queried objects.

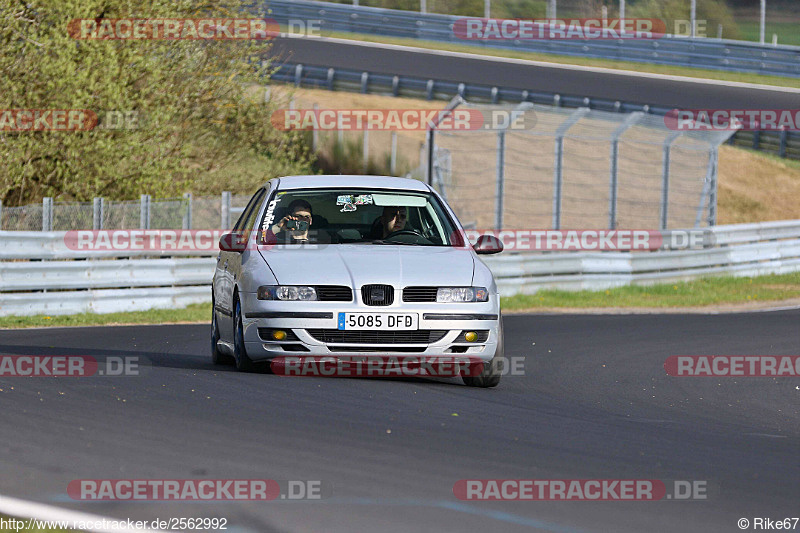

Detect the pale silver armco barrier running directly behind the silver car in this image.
[0,220,800,316]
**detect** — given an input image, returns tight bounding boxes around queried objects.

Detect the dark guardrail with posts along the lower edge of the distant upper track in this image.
[271,62,800,159]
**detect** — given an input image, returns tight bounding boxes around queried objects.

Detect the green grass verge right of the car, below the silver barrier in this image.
[502,272,800,311]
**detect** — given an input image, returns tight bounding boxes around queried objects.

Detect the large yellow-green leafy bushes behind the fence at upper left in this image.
[0,0,318,205]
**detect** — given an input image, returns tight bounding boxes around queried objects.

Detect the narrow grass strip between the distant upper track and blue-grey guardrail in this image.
[310,32,800,88]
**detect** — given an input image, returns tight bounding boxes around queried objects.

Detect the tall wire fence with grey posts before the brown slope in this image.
[429,102,733,229]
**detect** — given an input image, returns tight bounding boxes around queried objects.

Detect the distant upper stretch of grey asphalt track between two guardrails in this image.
[271,38,800,109]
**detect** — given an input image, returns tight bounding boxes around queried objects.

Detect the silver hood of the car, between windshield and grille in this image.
[259,244,474,288]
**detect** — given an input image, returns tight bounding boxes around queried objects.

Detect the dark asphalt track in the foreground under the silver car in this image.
[0,311,800,533]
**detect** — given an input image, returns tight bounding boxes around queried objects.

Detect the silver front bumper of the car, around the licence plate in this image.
[241,293,501,361]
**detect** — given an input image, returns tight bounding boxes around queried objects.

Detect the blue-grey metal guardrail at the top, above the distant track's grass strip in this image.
[260,0,800,77]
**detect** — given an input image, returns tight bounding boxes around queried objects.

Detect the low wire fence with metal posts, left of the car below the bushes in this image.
[0,192,250,231]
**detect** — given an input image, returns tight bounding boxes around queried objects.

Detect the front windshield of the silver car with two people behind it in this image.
[259,188,460,246]
